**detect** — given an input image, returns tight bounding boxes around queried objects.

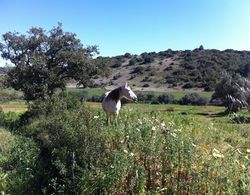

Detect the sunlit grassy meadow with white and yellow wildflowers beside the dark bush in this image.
[0,95,250,194]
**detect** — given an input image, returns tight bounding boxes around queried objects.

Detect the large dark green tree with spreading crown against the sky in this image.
[0,23,105,100]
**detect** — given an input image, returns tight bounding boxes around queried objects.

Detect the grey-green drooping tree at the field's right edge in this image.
[212,73,250,112]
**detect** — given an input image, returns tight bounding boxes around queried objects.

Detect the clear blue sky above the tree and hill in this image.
[0,0,250,62]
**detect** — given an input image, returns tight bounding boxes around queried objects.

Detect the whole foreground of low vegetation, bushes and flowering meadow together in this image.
[0,94,250,194]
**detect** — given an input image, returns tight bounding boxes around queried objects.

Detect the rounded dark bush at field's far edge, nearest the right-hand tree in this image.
[179,93,208,106]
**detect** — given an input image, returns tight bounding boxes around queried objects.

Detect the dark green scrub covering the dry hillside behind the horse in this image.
[104,45,250,91]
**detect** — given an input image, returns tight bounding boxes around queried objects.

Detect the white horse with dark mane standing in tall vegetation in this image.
[102,83,137,125]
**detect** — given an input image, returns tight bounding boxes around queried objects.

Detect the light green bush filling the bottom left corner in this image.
[0,129,42,194]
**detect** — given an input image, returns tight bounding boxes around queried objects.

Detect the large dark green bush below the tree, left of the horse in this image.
[13,94,133,194]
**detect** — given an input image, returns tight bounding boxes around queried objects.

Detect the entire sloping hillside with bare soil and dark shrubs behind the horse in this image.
[95,46,250,91]
